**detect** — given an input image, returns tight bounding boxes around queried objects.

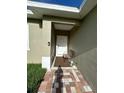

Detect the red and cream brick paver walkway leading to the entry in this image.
[38,67,93,93]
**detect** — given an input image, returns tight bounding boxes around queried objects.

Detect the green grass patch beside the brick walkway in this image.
[27,64,46,93]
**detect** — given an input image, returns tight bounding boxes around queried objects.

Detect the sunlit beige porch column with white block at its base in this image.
[41,20,51,70]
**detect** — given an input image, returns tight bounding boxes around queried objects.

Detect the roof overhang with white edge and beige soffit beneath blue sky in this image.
[27,0,97,19]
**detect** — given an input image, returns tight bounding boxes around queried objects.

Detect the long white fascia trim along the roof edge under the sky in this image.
[27,1,79,13]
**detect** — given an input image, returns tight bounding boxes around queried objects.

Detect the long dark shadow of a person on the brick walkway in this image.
[52,65,63,93]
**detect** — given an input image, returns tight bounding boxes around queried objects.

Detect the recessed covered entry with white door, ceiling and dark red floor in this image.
[51,22,76,67]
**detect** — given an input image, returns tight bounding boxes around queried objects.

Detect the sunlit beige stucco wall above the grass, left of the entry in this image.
[27,20,51,63]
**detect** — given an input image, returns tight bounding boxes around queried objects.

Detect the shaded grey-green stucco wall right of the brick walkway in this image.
[69,7,97,91]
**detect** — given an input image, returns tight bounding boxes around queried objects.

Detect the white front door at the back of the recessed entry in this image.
[56,35,68,57]
